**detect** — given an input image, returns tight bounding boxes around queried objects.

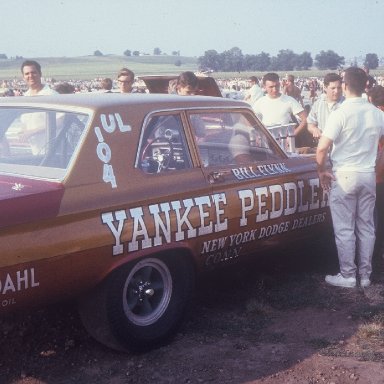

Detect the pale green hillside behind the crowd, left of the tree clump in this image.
[0,55,198,80]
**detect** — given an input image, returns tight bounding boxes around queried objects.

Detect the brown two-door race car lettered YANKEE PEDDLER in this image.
[0,94,331,350]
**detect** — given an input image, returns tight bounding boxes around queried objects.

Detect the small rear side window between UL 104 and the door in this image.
[138,115,191,173]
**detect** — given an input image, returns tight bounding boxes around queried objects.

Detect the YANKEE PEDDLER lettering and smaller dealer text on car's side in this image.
[101,178,328,263]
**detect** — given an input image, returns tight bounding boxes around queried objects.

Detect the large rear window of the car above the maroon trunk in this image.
[0,108,89,179]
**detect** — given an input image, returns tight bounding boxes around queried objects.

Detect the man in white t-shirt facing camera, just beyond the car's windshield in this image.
[253,72,307,136]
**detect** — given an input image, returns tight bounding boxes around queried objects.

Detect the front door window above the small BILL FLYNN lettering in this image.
[189,112,281,167]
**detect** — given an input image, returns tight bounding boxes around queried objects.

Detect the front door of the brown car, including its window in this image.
[188,109,327,267]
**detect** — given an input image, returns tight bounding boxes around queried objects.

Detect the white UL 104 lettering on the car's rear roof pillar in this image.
[94,113,132,188]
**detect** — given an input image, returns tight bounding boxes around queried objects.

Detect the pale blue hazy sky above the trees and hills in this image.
[0,0,384,59]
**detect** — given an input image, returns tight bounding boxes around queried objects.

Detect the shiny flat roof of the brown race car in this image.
[0,92,249,110]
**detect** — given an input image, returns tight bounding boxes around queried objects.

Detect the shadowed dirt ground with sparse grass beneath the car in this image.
[0,243,384,384]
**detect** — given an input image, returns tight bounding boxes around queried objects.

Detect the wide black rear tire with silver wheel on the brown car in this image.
[80,254,194,351]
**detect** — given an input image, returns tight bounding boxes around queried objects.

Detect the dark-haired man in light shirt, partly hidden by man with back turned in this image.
[307,73,344,139]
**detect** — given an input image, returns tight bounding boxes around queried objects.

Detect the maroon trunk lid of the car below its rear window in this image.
[0,174,64,228]
